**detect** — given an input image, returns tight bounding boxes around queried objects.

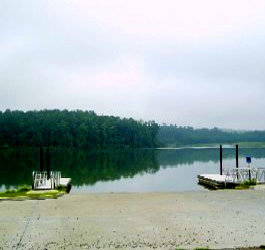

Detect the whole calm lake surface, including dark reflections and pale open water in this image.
[0,148,265,192]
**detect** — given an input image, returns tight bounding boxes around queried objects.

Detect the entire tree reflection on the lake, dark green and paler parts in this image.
[0,148,265,189]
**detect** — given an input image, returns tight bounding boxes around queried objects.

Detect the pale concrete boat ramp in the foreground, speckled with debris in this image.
[0,190,265,249]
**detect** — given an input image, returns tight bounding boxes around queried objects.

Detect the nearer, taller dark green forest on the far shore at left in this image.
[0,110,159,149]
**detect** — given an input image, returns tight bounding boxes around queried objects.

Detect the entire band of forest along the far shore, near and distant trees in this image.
[0,110,265,149]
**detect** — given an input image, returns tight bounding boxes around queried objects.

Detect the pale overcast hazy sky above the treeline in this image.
[0,0,265,129]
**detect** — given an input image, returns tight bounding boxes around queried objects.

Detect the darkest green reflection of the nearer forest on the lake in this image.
[0,149,159,187]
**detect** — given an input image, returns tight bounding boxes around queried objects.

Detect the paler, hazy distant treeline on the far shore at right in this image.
[157,125,265,146]
